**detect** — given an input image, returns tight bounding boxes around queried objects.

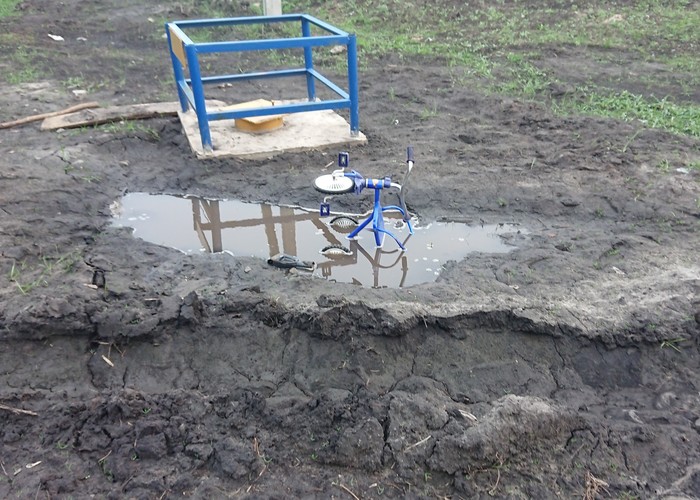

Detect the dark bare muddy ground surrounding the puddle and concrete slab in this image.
[0,0,700,498]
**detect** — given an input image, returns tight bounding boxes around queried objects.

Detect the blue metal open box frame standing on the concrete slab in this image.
[165,14,360,151]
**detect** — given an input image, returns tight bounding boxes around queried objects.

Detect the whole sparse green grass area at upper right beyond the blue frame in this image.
[285,0,700,115]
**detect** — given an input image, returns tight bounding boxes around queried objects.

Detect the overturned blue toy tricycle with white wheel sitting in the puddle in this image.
[314,146,413,251]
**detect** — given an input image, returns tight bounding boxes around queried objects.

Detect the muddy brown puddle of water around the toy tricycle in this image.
[112,193,526,288]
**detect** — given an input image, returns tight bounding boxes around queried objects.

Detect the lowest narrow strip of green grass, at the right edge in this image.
[554,89,700,137]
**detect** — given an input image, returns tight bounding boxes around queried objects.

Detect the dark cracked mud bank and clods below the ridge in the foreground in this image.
[0,292,700,497]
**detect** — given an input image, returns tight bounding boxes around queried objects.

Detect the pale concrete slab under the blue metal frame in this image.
[178,102,367,159]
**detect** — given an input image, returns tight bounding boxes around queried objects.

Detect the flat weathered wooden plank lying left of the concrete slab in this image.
[41,102,180,130]
